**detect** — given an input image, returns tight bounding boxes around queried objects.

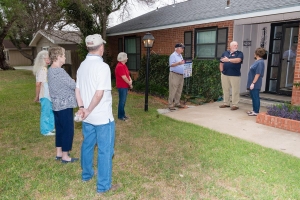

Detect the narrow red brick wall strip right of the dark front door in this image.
[292,24,300,105]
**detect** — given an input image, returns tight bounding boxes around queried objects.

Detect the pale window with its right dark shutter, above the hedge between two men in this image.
[195,28,228,59]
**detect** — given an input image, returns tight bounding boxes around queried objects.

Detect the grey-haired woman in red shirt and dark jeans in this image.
[115,52,132,121]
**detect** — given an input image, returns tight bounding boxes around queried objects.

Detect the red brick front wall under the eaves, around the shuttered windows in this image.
[107,20,233,68]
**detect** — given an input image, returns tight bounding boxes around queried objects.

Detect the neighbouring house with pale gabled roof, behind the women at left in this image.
[29,30,81,78]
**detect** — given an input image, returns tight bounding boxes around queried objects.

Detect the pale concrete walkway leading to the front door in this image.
[160,102,300,158]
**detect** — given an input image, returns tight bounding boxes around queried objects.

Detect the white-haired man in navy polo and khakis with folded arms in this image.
[219,41,244,110]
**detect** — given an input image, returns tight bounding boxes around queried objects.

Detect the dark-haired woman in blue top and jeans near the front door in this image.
[247,47,266,116]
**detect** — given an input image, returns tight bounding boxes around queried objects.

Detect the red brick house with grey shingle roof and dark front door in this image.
[107,0,300,104]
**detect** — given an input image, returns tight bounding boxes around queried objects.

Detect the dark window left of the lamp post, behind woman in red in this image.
[124,37,141,71]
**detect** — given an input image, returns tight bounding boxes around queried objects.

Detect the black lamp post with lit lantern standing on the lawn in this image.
[143,33,154,111]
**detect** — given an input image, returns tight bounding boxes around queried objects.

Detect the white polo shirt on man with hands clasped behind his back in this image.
[76,55,114,125]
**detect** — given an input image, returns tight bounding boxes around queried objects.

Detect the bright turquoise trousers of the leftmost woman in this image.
[40,98,54,135]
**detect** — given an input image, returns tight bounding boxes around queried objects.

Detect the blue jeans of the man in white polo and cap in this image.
[81,121,115,192]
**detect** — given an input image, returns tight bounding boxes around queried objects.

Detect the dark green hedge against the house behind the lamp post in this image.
[134,54,222,102]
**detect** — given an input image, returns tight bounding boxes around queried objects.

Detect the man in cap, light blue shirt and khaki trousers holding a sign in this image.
[168,44,185,110]
